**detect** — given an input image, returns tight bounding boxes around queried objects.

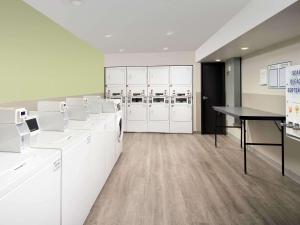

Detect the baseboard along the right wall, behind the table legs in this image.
[228,134,300,184]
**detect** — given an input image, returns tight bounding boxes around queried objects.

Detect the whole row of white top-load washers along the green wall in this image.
[0,96,123,225]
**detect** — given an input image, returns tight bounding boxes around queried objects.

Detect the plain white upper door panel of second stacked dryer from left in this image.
[127,67,147,85]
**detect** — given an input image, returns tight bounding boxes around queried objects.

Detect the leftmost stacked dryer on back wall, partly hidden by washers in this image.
[105,67,127,131]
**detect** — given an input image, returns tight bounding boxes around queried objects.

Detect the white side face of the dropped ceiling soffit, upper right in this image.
[195,0,297,62]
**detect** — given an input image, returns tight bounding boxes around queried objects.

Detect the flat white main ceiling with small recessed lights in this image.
[24,0,249,53]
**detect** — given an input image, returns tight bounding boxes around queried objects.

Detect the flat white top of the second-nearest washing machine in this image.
[30,130,90,150]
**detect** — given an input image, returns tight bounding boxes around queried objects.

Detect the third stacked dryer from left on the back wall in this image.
[148,66,170,133]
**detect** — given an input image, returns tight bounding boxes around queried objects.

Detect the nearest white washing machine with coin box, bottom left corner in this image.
[0,108,61,225]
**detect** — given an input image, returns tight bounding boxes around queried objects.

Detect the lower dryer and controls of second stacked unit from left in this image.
[127,85,148,132]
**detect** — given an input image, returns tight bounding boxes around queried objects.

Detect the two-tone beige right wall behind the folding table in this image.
[240,40,300,180]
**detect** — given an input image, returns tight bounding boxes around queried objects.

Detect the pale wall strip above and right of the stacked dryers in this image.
[104,51,200,131]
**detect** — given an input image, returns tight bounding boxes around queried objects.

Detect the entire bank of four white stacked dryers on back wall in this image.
[105,66,193,133]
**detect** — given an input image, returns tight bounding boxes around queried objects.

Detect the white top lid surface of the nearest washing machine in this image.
[0,148,60,198]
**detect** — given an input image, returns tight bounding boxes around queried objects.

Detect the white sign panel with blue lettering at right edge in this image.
[286,65,300,140]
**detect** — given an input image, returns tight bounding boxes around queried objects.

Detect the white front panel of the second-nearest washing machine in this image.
[62,138,91,225]
